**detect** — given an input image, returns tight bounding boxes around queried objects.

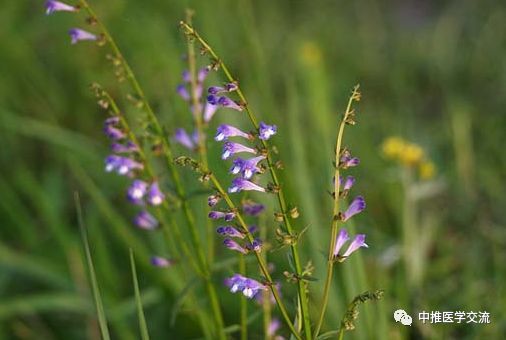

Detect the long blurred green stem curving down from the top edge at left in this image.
[80,0,226,339]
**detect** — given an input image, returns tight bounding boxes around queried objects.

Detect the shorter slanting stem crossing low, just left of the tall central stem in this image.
[210,173,302,340]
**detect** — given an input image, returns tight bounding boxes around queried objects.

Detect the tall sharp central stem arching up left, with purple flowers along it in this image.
[180,22,312,340]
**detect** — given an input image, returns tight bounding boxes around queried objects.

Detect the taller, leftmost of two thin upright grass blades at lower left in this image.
[74,192,110,340]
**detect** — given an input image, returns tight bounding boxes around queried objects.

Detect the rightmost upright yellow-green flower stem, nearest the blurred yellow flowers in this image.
[314,85,360,338]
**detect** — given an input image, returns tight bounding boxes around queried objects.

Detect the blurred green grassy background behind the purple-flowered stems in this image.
[0,0,506,339]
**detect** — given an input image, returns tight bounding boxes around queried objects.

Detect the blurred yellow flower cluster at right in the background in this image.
[381,137,436,180]
